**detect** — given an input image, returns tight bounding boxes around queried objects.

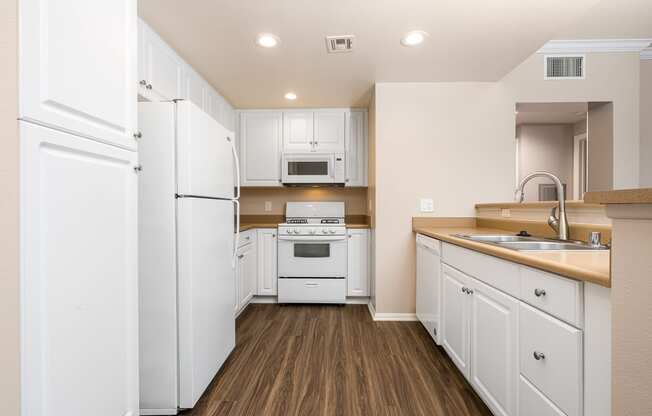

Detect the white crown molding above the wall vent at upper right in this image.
[537,39,652,54]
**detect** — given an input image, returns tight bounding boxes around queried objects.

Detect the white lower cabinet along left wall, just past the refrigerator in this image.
[235,230,258,315]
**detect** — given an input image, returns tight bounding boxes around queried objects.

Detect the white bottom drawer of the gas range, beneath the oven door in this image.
[278,278,346,303]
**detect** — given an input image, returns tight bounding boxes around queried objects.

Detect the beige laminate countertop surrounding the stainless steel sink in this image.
[414,226,611,287]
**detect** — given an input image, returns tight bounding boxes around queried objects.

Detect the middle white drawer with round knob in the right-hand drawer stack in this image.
[519,302,582,416]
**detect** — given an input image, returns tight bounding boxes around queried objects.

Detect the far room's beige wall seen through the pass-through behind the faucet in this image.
[516,124,573,201]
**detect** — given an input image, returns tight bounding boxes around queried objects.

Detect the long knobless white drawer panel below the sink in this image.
[442,243,519,298]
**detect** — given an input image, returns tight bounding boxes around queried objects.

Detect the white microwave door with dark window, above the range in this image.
[282,154,335,185]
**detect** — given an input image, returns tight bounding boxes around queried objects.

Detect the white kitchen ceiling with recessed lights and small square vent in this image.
[139,0,652,108]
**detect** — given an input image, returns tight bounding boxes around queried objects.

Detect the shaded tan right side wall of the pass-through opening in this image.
[587,103,615,192]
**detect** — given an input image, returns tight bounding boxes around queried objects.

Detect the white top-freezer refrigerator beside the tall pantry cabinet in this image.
[138,101,240,415]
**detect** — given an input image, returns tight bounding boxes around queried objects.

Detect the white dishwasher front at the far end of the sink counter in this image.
[416,242,441,343]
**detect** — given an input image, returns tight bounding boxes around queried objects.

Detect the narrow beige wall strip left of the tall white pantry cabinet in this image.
[0,0,20,416]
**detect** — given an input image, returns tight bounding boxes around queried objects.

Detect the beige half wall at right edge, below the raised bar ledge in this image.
[607,205,652,416]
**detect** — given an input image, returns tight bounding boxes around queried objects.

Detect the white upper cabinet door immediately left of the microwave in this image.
[240,111,283,186]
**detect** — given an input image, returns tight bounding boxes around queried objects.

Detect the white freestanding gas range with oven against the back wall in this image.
[278,202,347,303]
